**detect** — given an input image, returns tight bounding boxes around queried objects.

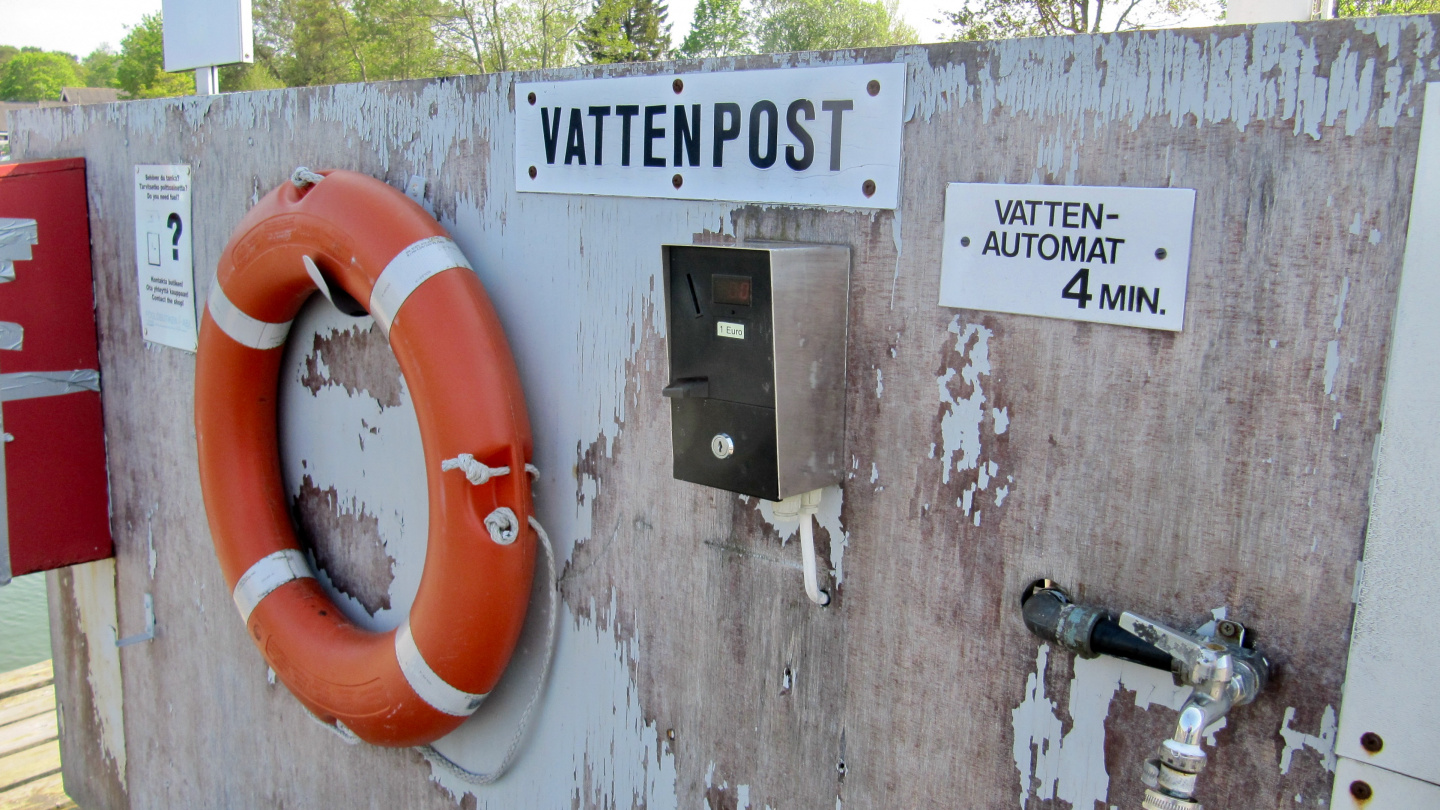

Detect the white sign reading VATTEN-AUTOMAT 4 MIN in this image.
[940,183,1195,331]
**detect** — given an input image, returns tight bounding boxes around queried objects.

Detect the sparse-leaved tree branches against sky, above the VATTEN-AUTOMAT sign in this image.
[936,0,1224,40]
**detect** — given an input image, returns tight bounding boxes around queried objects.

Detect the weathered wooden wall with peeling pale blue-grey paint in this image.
[14,17,1440,810]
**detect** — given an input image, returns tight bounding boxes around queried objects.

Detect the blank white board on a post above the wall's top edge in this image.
[162,0,255,72]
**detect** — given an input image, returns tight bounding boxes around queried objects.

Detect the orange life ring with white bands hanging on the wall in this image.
[194,170,536,747]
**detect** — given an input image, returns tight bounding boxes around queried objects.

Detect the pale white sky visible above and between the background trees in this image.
[0,0,1208,58]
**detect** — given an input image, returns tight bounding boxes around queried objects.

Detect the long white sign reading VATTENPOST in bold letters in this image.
[516,62,906,209]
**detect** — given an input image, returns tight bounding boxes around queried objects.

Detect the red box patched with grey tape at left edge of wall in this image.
[0,159,114,584]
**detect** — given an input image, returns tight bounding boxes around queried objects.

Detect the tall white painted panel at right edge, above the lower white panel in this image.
[1338,82,1440,783]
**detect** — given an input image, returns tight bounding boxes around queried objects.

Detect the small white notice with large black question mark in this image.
[135,166,199,352]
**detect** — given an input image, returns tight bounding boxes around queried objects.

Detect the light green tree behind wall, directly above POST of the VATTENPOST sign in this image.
[756,0,919,53]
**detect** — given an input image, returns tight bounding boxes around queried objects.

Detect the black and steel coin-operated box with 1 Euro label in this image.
[661,242,850,500]
